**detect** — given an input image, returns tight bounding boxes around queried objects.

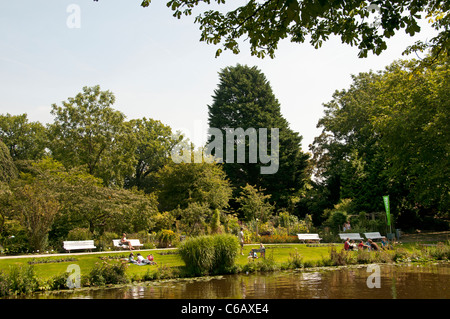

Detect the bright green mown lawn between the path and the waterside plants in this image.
[0,244,340,280]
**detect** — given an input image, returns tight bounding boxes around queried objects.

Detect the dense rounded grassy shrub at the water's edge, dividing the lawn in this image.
[179,234,239,275]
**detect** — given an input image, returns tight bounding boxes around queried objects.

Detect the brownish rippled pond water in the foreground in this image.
[15,263,450,299]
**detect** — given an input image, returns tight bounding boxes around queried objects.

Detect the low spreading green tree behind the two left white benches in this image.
[14,158,157,239]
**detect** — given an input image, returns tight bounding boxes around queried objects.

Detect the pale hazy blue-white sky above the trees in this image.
[0,0,435,151]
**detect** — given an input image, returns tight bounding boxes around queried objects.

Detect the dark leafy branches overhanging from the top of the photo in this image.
[141,0,450,57]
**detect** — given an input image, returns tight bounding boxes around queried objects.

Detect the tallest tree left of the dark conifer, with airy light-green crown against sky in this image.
[49,85,136,186]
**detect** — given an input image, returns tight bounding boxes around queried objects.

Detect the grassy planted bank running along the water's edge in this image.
[0,242,450,295]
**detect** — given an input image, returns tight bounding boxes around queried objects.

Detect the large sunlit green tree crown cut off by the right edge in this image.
[373,58,450,213]
